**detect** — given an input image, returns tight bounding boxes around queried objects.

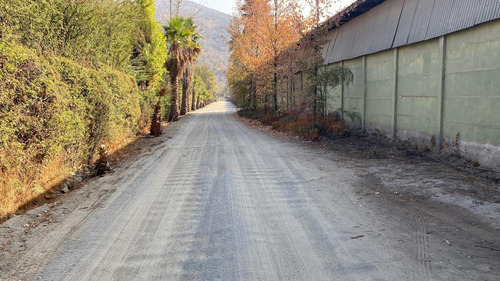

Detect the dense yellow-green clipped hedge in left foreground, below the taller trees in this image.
[0,41,145,219]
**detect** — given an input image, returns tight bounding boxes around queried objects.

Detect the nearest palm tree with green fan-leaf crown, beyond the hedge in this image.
[163,17,201,121]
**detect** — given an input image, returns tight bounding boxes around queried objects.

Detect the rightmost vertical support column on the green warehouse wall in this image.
[435,36,446,150]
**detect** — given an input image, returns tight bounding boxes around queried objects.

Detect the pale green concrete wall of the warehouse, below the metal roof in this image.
[320,20,500,169]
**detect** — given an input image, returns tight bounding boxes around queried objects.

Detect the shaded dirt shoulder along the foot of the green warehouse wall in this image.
[234,114,500,230]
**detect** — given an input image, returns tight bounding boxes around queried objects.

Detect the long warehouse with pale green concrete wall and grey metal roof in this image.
[297,0,500,169]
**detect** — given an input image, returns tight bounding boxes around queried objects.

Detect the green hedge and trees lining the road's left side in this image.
[0,0,215,221]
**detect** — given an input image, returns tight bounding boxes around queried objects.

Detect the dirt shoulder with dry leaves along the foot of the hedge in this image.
[0,114,192,280]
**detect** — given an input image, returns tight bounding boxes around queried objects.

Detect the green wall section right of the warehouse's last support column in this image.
[443,21,500,146]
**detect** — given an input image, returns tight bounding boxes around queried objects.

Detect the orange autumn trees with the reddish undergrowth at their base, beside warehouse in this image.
[227,0,353,136]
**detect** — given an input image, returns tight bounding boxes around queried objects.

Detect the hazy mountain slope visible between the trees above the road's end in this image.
[155,0,231,91]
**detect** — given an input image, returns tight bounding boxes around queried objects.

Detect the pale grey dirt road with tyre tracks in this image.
[0,102,500,281]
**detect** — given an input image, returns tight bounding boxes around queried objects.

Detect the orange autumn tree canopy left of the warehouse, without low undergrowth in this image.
[227,0,350,118]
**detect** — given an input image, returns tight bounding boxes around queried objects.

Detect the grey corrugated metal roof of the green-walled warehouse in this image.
[323,0,500,63]
